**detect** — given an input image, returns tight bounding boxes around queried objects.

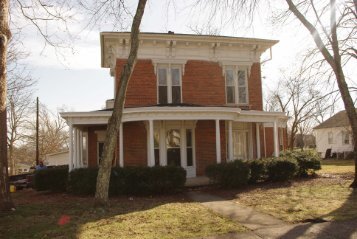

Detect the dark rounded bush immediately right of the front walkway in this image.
[206,160,250,188]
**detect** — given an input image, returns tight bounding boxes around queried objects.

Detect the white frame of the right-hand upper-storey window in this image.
[224,66,249,105]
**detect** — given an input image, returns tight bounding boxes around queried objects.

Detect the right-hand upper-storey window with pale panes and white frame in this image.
[225,67,248,104]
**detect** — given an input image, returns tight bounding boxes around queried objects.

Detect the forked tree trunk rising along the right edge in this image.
[286,0,357,188]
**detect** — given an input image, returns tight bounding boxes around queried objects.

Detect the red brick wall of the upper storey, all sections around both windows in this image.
[115,59,263,110]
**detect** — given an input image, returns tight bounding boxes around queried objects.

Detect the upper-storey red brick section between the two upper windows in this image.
[182,61,226,105]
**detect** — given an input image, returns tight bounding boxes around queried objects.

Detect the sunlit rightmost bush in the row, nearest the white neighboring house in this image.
[280,150,321,177]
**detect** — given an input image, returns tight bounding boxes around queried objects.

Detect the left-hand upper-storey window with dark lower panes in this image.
[157,65,182,104]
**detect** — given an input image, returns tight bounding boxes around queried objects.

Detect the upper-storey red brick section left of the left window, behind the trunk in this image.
[115,59,157,107]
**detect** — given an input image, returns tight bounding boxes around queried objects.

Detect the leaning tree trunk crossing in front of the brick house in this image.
[94,0,146,207]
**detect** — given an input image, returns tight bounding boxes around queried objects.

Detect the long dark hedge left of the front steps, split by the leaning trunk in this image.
[68,166,186,195]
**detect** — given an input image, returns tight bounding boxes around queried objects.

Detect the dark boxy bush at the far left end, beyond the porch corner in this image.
[34,166,68,192]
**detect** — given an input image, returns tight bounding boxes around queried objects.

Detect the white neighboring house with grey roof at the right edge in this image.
[314,110,353,157]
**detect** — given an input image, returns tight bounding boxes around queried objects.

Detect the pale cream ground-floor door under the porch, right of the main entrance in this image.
[233,130,248,160]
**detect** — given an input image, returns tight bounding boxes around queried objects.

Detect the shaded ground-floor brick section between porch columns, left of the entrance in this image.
[123,121,147,166]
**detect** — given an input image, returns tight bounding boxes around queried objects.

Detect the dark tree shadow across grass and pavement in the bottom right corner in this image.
[282,189,357,239]
